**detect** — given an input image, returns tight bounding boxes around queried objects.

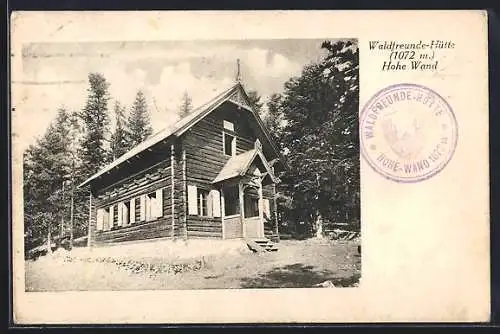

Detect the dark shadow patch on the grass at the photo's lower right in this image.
[240,263,360,288]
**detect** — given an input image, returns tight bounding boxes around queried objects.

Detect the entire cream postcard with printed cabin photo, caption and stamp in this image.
[10,10,490,324]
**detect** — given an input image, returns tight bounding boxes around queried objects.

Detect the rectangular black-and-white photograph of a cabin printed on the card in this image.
[20,38,361,291]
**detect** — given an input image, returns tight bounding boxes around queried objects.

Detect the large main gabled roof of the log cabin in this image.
[78,82,285,188]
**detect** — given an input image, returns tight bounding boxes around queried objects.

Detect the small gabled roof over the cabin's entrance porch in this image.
[212,148,277,183]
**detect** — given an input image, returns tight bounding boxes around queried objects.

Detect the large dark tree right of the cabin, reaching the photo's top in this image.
[279,42,359,237]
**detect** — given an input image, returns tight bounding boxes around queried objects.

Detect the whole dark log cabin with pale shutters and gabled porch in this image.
[79,82,285,245]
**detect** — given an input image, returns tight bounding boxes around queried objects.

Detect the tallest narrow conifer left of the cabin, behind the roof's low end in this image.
[80,73,109,178]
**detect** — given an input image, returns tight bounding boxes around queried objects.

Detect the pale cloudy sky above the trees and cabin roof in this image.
[12,39,334,149]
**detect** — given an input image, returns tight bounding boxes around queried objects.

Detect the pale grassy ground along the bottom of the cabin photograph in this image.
[25,239,361,291]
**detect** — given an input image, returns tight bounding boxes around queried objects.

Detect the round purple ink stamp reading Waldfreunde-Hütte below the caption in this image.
[359,84,458,182]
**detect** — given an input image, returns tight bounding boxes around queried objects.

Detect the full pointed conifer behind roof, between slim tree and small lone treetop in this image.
[128,91,153,147]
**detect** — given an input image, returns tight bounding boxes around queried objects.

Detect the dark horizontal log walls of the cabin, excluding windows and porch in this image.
[89,102,282,245]
